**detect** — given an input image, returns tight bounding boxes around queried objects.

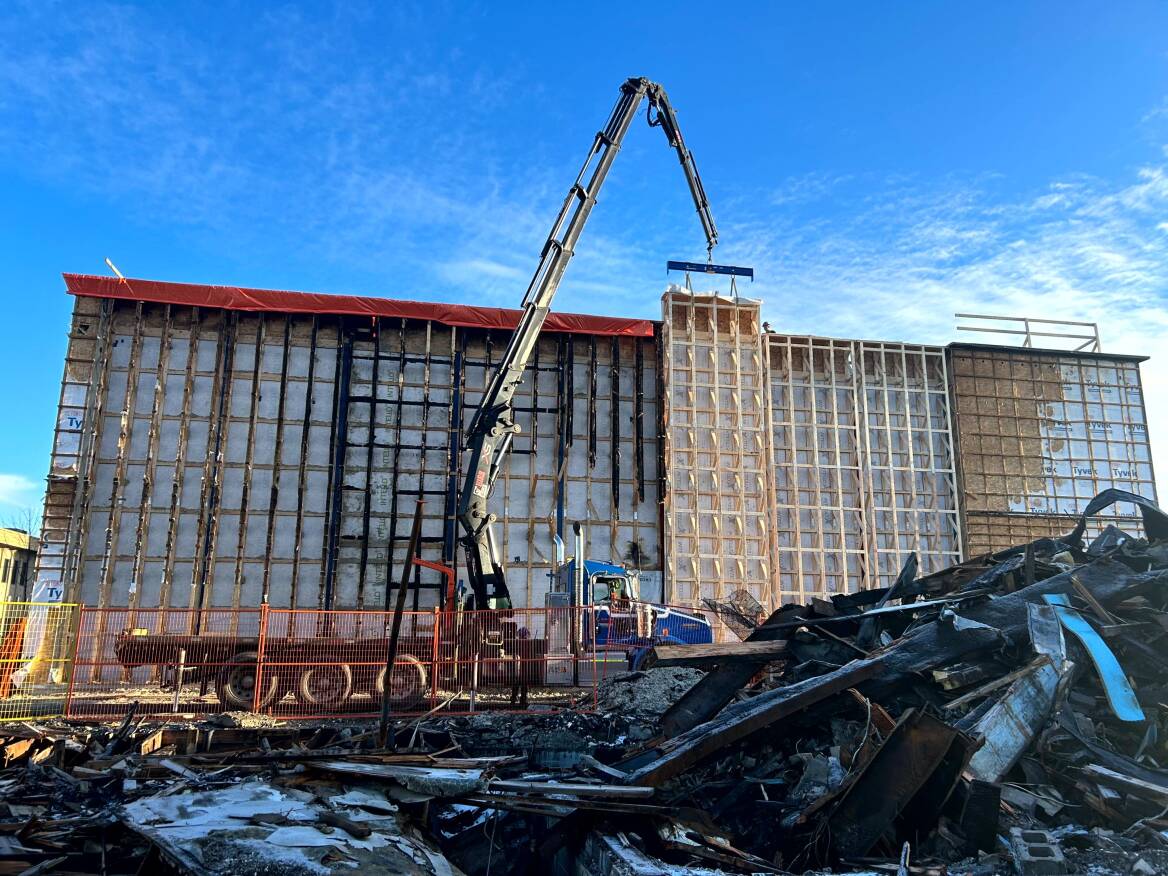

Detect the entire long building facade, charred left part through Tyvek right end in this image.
[35,274,1155,609]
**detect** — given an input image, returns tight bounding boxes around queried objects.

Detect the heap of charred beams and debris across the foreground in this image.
[0,491,1168,876]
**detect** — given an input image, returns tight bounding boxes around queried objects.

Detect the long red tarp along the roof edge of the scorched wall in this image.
[62,273,653,338]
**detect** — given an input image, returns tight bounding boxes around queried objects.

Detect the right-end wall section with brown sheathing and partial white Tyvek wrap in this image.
[950,345,1156,554]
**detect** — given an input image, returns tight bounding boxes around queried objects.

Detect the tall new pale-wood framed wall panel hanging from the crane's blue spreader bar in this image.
[662,290,774,605]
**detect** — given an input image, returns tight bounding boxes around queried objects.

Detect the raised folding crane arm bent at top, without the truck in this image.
[458,78,718,609]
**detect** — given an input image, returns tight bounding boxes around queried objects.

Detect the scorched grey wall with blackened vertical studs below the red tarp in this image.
[52,297,661,607]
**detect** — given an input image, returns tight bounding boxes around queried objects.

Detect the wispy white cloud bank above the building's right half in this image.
[726,166,1168,490]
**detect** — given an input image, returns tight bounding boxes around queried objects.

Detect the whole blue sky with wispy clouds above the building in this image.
[0,0,1168,513]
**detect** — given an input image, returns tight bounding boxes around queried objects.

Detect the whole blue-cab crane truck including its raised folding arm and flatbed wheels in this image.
[116,77,724,711]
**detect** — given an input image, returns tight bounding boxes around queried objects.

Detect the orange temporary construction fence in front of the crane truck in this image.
[67,605,714,718]
